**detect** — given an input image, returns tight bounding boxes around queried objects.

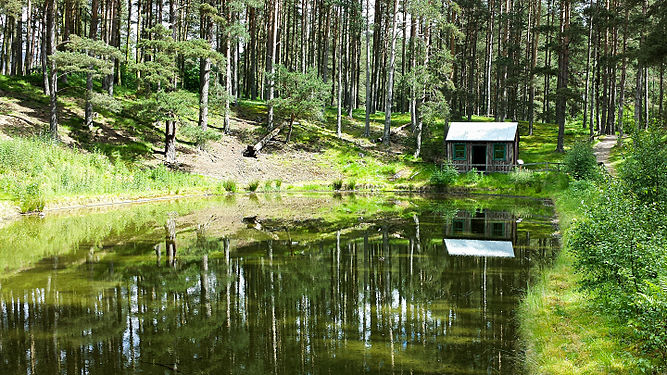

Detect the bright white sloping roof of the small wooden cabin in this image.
[447,122,519,142]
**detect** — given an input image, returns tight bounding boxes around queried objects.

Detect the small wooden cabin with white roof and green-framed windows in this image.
[446,122,519,172]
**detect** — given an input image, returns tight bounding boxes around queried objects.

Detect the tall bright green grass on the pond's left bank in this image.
[0,138,208,212]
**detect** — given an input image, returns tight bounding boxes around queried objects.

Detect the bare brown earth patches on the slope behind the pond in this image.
[0,92,340,184]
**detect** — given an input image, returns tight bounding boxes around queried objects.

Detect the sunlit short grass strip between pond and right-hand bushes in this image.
[518,185,647,375]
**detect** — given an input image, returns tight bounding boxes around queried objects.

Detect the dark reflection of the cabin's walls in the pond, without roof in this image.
[445,210,516,242]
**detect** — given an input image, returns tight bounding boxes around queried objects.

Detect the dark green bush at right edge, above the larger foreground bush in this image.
[619,131,667,208]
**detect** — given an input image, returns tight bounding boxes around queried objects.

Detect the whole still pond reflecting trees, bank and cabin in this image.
[0,194,559,375]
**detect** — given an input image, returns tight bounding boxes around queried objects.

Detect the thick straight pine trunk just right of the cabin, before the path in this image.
[556,0,570,152]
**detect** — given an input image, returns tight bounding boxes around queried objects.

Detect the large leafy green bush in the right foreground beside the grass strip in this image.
[567,180,667,365]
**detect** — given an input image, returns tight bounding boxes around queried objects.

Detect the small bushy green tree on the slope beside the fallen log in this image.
[270,65,329,142]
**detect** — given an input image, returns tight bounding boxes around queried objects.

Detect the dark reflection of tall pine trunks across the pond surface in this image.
[0,215,553,374]
